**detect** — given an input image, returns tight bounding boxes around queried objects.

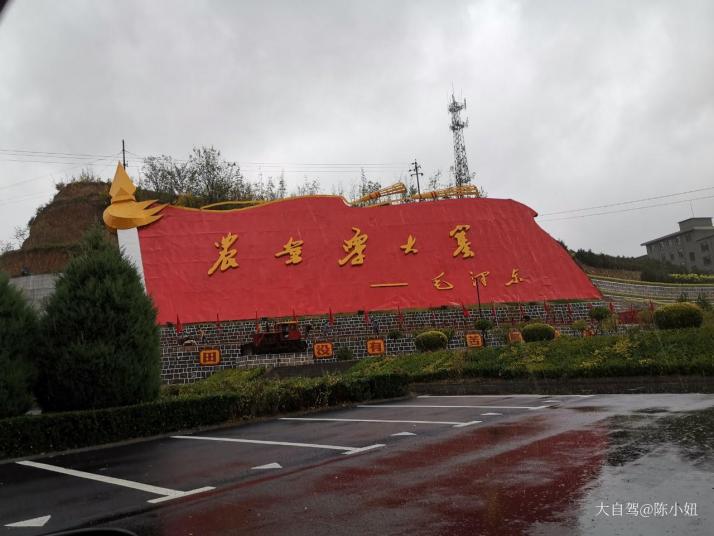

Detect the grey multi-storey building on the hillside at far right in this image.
[641,218,714,273]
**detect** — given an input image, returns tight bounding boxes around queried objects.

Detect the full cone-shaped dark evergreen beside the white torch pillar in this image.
[36,229,161,411]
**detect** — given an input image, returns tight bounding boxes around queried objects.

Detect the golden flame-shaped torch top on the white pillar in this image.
[102,164,166,229]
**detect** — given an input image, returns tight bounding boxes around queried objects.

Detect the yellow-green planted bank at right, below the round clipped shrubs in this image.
[348,326,714,382]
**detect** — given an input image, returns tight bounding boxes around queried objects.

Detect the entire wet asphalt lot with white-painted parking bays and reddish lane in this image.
[0,394,714,536]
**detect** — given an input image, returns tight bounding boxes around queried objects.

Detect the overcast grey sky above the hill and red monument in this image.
[0,0,714,255]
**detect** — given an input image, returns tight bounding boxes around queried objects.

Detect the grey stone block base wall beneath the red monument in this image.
[161,302,602,383]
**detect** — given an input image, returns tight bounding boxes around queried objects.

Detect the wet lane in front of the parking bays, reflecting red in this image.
[80,395,714,536]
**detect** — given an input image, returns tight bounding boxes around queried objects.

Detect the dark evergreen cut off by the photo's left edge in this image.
[0,273,37,419]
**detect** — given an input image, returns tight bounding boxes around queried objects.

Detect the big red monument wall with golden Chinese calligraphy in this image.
[138,196,601,323]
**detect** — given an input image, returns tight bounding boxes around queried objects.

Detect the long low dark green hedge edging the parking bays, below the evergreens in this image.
[0,374,407,459]
